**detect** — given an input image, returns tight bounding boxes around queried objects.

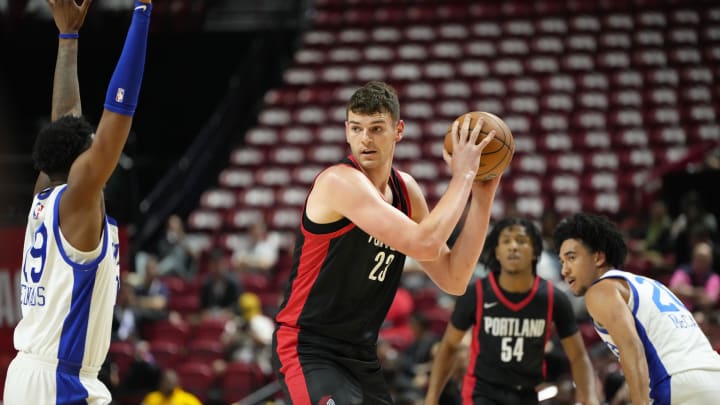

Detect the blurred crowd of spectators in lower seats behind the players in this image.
[105,192,720,405]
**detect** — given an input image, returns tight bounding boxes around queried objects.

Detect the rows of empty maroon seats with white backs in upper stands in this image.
[189,0,720,249]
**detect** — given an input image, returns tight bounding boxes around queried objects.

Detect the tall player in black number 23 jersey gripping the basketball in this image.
[273,82,512,405]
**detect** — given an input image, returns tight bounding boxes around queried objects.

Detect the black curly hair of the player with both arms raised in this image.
[32,115,94,178]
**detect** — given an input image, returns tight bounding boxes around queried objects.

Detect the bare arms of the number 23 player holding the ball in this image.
[308,120,497,295]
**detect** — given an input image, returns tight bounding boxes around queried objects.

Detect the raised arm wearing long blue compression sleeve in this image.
[60,0,152,250]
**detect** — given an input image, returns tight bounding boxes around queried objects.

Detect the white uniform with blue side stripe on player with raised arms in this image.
[4,185,119,405]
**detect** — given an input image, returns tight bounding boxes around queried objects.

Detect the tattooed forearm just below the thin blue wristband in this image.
[50,38,82,121]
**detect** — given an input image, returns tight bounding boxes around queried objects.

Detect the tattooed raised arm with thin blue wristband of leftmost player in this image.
[33,0,92,194]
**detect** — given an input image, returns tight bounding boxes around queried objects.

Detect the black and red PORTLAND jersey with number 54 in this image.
[451,273,577,398]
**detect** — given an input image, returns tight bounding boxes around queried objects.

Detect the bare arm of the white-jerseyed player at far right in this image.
[585,279,650,405]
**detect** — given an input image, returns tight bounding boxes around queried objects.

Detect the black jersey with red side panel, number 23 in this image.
[276,157,411,345]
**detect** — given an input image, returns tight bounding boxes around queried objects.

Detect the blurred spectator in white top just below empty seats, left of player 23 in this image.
[232,218,280,272]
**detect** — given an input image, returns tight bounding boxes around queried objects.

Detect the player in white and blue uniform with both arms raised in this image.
[4,0,152,405]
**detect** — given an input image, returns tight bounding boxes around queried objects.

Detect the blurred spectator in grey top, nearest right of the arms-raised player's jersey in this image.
[157,215,197,279]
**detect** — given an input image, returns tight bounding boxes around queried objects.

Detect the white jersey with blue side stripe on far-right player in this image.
[595,270,720,405]
